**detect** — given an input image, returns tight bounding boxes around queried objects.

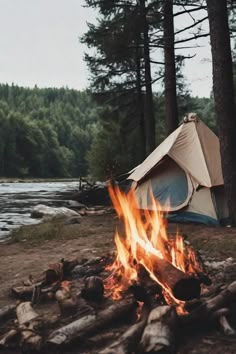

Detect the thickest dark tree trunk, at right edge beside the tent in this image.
[207,0,236,225]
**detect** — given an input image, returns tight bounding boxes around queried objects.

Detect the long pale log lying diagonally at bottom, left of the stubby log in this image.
[47,299,137,351]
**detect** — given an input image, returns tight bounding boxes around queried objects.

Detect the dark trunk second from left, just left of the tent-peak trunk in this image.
[139,0,155,154]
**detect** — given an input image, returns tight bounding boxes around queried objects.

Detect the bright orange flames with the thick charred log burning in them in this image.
[106,187,203,304]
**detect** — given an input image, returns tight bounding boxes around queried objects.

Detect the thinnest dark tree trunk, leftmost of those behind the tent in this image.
[136,37,146,162]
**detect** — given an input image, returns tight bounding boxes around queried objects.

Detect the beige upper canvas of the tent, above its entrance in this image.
[128,120,224,187]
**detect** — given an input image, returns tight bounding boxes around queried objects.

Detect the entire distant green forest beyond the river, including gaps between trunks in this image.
[0,84,215,179]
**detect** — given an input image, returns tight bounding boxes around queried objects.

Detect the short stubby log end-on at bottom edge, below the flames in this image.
[139,306,178,354]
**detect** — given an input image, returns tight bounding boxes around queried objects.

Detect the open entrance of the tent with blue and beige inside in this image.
[135,156,193,211]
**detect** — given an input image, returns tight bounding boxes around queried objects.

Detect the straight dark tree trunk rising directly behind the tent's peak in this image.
[163,0,178,135]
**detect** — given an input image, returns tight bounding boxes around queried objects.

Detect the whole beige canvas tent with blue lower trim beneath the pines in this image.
[128,114,228,225]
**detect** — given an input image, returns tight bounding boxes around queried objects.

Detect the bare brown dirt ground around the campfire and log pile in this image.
[0,213,236,354]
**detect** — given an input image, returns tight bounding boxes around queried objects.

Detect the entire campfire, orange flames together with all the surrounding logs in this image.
[0,187,236,354]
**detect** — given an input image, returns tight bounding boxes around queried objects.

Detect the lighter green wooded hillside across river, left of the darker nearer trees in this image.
[0,85,99,178]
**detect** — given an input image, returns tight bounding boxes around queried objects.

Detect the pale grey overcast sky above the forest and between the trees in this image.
[0,0,212,97]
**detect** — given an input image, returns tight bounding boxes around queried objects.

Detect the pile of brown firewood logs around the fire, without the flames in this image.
[0,255,236,354]
